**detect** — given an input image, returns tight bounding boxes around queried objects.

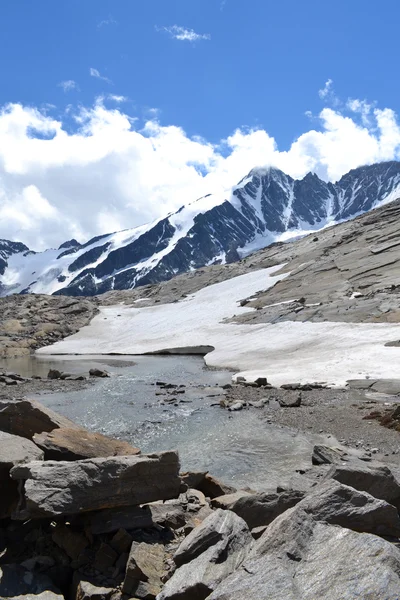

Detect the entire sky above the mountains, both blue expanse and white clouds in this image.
[0,0,400,248]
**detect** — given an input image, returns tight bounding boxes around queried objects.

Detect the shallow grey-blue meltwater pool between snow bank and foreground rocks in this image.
[0,356,332,490]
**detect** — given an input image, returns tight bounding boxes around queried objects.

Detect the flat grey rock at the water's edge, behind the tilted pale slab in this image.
[211,491,304,529]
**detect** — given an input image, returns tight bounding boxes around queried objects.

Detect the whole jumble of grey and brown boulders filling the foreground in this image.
[0,399,400,600]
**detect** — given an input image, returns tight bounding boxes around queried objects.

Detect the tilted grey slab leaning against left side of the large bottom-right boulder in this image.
[157,509,253,600]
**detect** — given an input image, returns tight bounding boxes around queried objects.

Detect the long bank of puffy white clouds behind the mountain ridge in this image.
[0,98,400,250]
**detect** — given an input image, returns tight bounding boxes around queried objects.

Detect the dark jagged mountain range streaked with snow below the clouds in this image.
[0,162,400,296]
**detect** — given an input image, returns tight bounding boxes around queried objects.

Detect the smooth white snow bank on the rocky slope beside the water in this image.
[38,265,400,385]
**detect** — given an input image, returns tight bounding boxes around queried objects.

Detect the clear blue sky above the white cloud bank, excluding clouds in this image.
[0,0,400,147]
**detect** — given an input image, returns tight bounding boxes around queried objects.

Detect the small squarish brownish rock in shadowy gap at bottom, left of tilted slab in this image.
[122,542,165,600]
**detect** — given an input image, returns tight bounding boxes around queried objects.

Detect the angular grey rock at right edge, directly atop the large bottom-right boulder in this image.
[296,480,400,537]
